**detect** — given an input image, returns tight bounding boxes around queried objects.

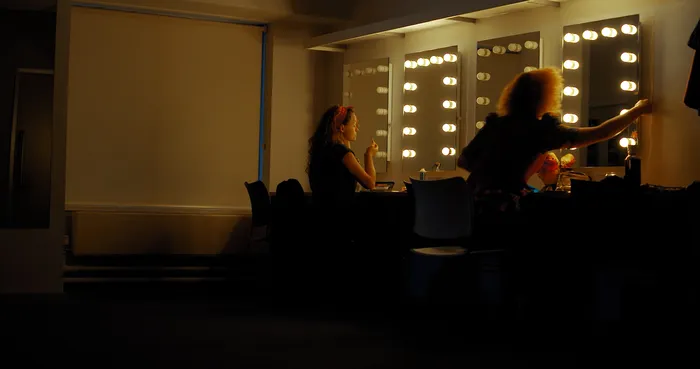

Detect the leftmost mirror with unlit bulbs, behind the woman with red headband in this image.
[343,58,391,173]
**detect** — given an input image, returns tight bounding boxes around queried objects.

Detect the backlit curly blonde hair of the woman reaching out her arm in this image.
[498,68,564,119]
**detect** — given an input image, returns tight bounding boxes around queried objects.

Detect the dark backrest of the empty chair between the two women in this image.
[407,177,474,240]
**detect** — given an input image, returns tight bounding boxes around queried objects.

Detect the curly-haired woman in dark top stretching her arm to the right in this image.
[458,68,651,212]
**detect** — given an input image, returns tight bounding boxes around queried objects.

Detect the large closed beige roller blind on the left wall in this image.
[66,7,262,207]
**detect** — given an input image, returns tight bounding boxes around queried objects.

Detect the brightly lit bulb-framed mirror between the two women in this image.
[401,46,460,175]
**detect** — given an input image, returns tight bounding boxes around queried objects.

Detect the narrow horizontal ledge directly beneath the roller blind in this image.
[66,202,252,216]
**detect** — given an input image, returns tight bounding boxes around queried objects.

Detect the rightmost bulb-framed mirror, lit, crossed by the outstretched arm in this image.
[562,15,641,167]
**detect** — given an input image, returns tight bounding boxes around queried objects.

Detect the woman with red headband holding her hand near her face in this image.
[307,105,378,211]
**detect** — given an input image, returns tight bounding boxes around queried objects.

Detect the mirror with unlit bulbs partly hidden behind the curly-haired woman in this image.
[470,32,542,132]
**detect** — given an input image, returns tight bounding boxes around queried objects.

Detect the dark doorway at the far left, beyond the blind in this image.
[0,1,56,227]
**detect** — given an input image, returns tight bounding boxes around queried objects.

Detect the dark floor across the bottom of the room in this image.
[0,284,697,369]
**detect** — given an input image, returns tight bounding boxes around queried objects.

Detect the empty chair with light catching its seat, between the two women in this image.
[406,177,474,299]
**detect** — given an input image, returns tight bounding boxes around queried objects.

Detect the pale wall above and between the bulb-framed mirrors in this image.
[332,0,700,186]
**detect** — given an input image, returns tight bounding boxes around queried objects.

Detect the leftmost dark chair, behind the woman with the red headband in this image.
[245,180,272,253]
